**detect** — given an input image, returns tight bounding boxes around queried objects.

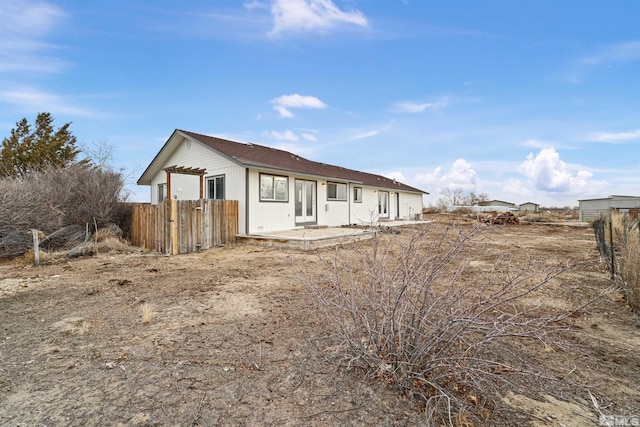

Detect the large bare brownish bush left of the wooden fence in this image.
[0,163,126,254]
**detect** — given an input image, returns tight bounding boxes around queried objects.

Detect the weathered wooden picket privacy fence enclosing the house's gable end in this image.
[131,199,238,255]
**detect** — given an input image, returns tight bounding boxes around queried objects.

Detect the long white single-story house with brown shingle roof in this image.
[138,129,428,234]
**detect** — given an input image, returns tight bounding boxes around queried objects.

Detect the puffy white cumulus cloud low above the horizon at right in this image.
[518,148,605,194]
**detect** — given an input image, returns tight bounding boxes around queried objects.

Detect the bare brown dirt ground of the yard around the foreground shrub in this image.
[0,219,640,426]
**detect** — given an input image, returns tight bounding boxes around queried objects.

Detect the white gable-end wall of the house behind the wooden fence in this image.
[150,141,246,233]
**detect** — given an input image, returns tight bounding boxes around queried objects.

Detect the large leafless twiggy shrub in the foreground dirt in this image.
[302,225,570,425]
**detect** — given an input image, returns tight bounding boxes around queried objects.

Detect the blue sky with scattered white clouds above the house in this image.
[0,0,640,206]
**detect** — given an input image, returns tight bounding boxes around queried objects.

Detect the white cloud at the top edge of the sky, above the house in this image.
[269,0,369,35]
